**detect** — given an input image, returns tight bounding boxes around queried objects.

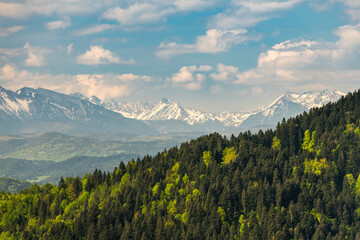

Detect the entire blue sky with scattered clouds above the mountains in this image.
[0,0,360,112]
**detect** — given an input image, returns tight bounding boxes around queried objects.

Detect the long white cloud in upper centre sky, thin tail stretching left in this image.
[155,29,259,59]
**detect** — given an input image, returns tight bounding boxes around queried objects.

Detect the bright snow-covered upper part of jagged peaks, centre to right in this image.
[97,90,345,128]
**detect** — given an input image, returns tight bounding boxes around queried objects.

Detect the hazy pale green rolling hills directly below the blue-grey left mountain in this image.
[0,132,183,162]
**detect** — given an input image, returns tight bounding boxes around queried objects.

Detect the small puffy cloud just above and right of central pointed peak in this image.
[171,65,213,90]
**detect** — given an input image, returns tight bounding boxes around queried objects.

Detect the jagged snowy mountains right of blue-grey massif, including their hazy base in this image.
[78,90,345,133]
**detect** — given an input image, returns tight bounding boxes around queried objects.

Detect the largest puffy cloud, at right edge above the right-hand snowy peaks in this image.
[235,24,360,87]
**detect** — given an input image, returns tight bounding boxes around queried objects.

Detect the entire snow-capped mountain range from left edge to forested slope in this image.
[0,87,345,136]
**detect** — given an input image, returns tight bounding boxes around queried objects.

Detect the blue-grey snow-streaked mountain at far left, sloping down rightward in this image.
[0,87,158,135]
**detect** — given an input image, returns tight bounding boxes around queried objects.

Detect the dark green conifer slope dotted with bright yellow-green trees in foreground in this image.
[0,92,360,239]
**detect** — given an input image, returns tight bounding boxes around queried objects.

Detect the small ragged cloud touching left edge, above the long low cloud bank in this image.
[0,42,52,67]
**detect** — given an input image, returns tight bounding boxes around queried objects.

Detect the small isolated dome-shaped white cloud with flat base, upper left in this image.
[76,46,135,65]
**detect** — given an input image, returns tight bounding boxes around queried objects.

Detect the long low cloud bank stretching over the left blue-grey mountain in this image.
[0,64,153,99]
